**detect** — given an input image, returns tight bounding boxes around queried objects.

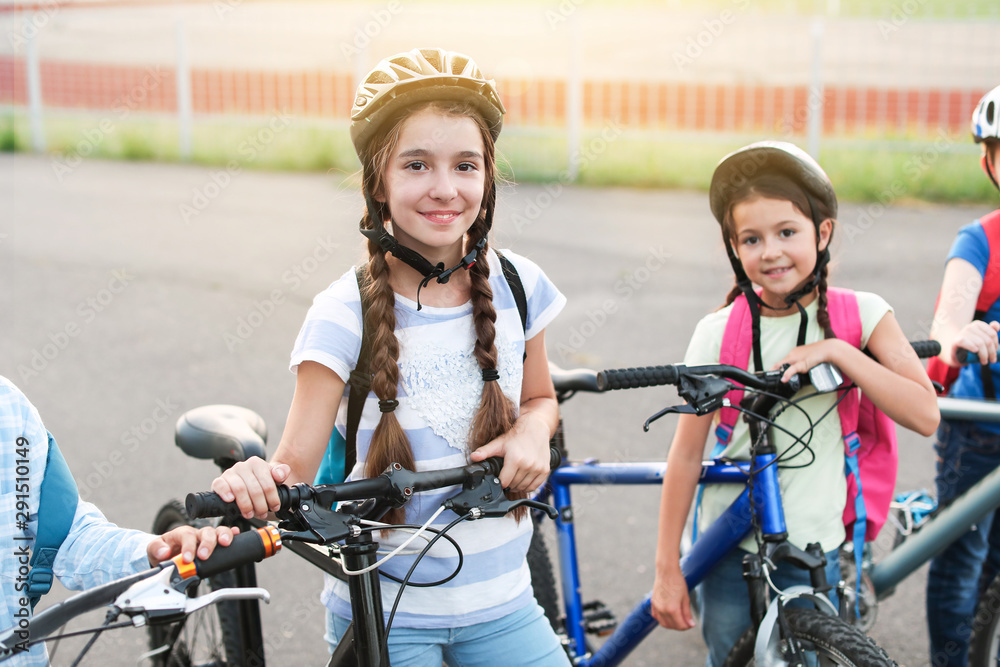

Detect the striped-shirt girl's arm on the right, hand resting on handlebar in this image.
[470,330,559,491]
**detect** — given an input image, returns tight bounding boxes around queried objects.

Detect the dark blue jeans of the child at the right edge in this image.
[927,421,1000,667]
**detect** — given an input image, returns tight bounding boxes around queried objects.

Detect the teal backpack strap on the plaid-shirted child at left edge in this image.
[27,431,80,609]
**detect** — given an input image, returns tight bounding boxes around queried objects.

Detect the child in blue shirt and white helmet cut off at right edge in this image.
[927,86,1000,667]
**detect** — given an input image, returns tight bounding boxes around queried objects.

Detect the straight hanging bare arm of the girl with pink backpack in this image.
[652,415,712,630]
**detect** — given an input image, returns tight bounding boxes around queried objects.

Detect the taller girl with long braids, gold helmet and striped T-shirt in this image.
[212,49,568,667]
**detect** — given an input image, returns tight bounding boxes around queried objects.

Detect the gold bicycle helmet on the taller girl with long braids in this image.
[351,49,506,156]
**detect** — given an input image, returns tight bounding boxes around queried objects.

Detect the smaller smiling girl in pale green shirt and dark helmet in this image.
[652,142,938,666]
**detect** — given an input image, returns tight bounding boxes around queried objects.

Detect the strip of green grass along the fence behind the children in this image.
[0,113,997,204]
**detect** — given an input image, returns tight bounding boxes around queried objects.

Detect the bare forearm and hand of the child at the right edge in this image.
[930,257,1000,366]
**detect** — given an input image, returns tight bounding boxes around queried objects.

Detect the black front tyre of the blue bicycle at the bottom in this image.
[725,609,896,667]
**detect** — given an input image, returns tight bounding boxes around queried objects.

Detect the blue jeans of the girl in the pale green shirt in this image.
[698,549,840,667]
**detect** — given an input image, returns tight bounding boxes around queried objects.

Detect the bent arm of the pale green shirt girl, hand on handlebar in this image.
[775,312,941,435]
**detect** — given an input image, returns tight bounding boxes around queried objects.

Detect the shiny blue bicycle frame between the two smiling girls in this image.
[536,454,786,667]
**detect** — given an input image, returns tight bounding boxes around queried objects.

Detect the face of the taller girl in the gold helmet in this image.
[378,109,486,264]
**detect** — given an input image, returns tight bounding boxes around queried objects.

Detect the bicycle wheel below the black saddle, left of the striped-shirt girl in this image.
[149,500,243,667]
